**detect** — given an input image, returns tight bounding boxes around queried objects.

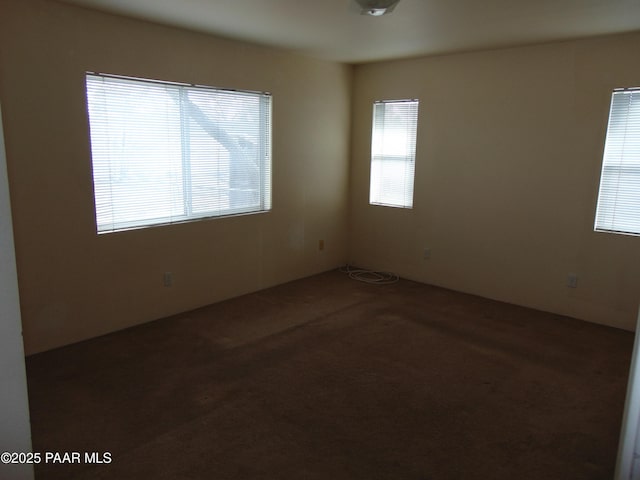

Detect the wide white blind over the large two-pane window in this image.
[86,73,271,233]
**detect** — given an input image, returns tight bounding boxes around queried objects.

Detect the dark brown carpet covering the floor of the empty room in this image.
[27,272,633,480]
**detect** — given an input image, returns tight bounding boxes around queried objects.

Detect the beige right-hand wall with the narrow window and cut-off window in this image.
[349,34,640,329]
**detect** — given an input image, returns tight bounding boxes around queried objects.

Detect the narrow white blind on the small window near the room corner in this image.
[369,100,418,208]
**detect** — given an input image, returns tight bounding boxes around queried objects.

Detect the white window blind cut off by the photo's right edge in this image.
[595,88,640,235]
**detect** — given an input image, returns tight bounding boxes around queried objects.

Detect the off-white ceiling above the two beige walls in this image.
[58,0,640,63]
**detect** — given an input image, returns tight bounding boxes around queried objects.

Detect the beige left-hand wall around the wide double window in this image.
[0,0,351,353]
